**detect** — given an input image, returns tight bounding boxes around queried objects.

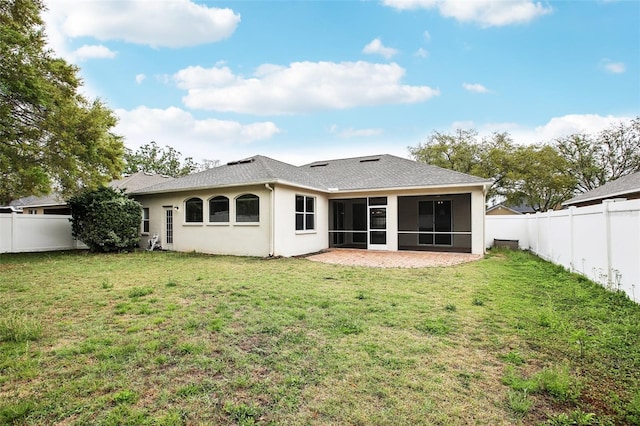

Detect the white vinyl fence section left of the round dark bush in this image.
[0,213,87,253]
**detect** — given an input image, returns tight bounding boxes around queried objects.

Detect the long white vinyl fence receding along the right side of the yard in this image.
[485,200,640,302]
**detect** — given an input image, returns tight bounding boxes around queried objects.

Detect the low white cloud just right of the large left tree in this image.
[114,106,281,160]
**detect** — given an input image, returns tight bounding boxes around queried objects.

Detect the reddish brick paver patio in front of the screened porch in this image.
[306,249,482,268]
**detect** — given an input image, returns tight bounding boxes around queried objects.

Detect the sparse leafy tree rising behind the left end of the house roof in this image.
[124,141,199,177]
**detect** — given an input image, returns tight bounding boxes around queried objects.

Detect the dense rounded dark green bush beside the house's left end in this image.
[68,186,142,252]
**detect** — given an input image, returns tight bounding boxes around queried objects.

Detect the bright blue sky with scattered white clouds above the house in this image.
[45,0,640,164]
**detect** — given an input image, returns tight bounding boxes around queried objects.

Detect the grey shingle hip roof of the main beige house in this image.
[132,154,491,194]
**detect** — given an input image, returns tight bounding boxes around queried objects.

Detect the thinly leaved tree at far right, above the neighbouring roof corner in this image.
[555,117,640,192]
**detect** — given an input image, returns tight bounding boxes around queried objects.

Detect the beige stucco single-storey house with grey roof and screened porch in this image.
[131,155,492,256]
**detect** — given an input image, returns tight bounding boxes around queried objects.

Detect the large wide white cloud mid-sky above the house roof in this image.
[173,61,440,115]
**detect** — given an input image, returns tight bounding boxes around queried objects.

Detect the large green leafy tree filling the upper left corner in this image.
[0,0,124,204]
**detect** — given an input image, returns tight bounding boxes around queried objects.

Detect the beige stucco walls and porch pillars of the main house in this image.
[136,184,485,256]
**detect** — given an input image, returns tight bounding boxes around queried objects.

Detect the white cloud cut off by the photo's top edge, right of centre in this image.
[383,0,551,27]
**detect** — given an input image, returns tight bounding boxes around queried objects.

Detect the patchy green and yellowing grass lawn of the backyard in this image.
[0,252,640,425]
